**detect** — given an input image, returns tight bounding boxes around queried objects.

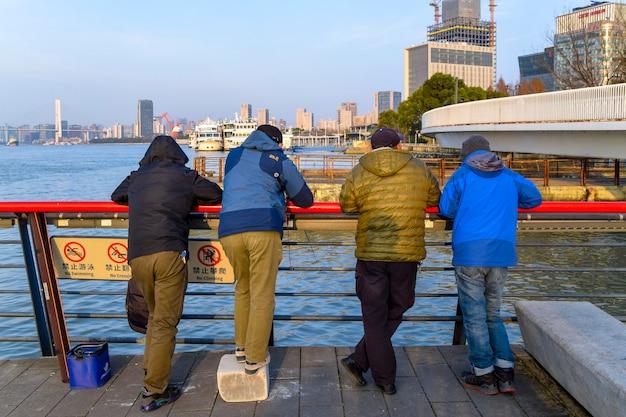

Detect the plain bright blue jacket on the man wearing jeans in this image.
[439,150,541,267]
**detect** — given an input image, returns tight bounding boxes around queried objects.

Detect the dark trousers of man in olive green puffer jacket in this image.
[350,260,418,385]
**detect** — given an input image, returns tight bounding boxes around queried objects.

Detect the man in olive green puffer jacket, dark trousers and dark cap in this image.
[339,128,441,395]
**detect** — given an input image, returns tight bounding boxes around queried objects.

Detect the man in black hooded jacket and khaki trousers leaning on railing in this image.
[111,136,222,411]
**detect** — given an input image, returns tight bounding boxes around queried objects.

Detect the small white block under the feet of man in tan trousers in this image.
[217,355,270,403]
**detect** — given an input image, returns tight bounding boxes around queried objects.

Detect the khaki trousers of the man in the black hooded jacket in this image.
[130,251,187,393]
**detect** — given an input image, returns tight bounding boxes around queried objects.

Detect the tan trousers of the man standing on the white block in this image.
[220,232,283,362]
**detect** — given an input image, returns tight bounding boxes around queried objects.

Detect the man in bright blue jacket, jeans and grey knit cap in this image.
[439,135,541,394]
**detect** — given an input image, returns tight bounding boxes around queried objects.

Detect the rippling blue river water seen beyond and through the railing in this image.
[0,144,626,359]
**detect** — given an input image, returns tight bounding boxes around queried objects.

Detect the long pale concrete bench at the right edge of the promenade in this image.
[515,301,626,417]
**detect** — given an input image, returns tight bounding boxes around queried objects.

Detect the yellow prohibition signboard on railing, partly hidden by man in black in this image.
[50,236,235,284]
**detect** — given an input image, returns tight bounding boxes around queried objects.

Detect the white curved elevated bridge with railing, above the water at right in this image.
[421,84,626,159]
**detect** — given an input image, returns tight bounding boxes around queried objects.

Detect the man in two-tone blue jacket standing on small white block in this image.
[218,125,313,374]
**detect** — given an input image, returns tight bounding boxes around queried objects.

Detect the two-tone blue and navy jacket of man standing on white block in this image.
[218,130,313,238]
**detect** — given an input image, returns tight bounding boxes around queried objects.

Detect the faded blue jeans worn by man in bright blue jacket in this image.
[454,266,514,376]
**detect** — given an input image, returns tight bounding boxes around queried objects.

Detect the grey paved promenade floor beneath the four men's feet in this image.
[0,345,588,417]
